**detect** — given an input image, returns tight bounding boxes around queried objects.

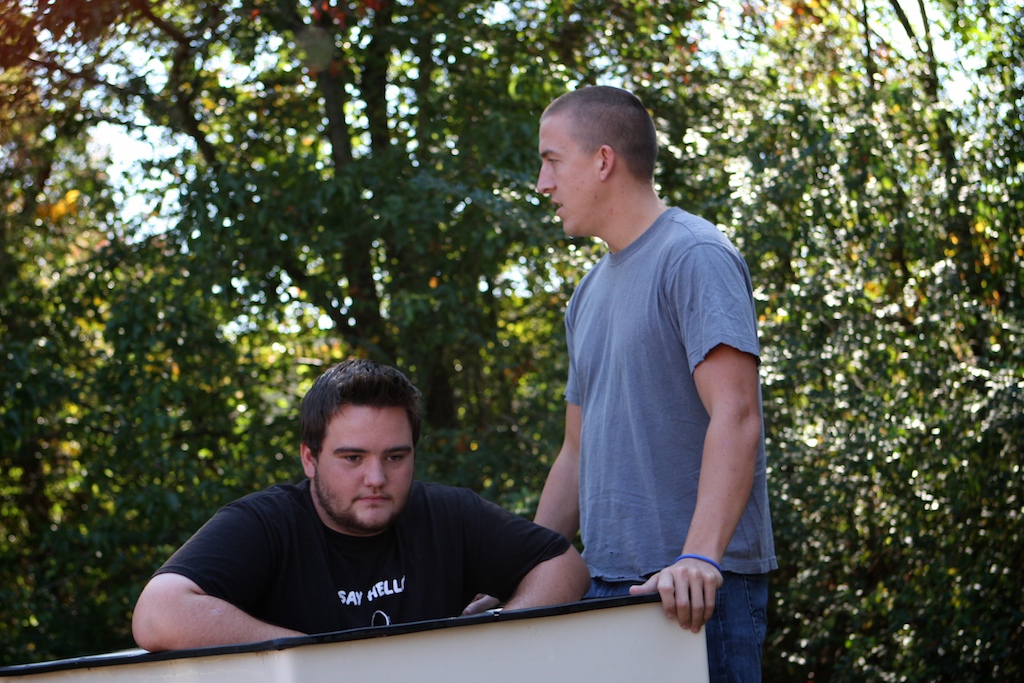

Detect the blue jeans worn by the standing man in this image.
[584,571,768,683]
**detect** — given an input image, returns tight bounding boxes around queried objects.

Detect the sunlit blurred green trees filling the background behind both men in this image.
[0,0,1024,681]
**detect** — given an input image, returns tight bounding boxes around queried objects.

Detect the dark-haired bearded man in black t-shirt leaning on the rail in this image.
[132,359,589,650]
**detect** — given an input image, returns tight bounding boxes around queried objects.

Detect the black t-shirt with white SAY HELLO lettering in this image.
[157,479,569,633]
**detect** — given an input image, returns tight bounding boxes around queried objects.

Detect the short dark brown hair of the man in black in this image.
[299,358,423,458]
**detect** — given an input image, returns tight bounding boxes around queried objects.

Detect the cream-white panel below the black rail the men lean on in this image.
[0,601,708,683]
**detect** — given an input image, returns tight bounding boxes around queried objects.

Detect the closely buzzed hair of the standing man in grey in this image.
[541,85,657,180]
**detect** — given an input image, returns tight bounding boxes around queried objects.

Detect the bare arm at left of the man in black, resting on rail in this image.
[131,573,303,652]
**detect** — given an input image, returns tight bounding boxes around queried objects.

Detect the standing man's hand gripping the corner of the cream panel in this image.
[630,558,725,633]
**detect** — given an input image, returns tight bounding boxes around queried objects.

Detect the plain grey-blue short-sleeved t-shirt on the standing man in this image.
[565,209,777,580]
